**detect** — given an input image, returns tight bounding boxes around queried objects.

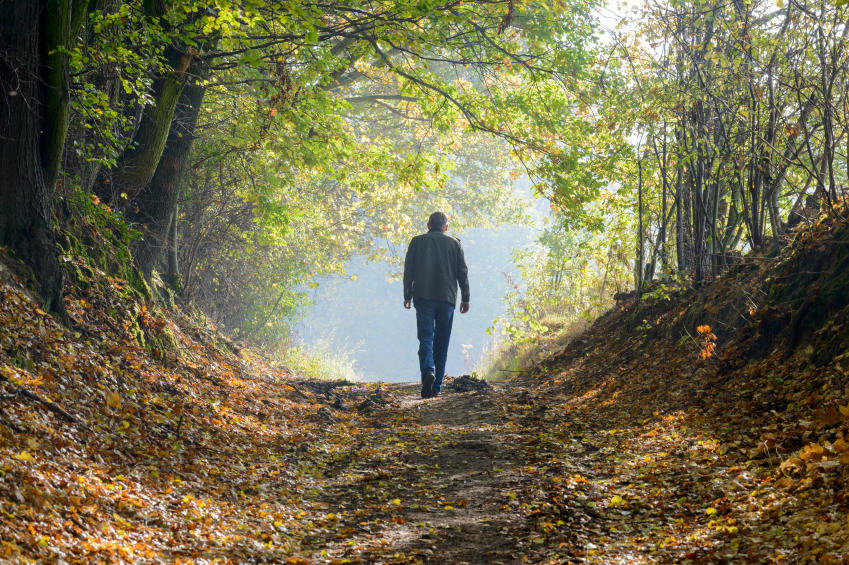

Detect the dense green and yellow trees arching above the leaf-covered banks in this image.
[0,0,849,374]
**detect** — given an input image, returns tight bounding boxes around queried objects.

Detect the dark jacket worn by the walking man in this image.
[404,229,469,304]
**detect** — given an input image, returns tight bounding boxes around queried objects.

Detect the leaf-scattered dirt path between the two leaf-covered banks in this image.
[307,384,596,564]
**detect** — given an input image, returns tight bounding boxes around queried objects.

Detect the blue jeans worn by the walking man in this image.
[414,300,454,394]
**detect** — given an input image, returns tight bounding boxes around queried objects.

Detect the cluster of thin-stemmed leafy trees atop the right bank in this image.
[592,0,847,281]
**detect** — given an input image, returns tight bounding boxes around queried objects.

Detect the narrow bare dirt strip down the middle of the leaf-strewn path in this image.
[390,387,522,563]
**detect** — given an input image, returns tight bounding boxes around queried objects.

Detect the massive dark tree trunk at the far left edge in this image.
[0,0,87,322]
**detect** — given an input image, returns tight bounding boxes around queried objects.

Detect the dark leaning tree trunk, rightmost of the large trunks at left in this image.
[128,72,205,280]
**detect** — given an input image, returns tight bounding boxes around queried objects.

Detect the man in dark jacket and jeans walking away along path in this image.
[404,212,469,398]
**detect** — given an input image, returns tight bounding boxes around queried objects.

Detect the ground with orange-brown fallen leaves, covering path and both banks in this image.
[0,214,849,563]
